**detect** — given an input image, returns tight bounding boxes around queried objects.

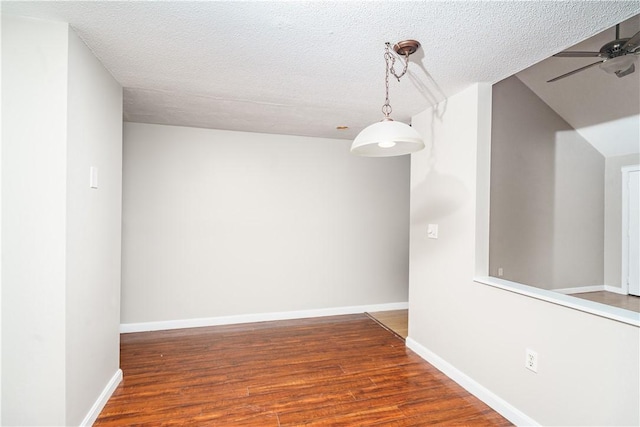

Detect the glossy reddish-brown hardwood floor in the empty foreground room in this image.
[94,314,511,427]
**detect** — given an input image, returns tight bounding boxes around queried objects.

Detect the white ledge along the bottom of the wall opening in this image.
[473,277,640,327]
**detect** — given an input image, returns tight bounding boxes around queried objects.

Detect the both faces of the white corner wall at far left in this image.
[1,15,122,425]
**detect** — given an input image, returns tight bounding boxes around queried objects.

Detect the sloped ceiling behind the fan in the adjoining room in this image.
[517,15,640,157]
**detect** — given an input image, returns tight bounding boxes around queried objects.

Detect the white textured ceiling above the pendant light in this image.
[1,1,640,139]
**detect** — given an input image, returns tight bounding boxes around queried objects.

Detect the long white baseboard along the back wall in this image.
[120,302,409,334]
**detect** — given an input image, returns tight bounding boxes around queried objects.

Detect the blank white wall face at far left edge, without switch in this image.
[2,15,68,425]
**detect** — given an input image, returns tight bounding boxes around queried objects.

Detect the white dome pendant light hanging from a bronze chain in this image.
[351,40,424,157]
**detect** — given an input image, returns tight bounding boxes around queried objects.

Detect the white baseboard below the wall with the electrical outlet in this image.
[405,337,540,426]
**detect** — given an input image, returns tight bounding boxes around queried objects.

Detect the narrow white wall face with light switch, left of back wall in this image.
[66,31,122,425]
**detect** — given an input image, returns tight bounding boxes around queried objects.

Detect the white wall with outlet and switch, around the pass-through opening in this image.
[407,84,640,425]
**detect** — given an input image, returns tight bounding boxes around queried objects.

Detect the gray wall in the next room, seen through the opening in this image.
[489,77,604,289]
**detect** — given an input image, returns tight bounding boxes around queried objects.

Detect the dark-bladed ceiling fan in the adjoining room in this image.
[547,24,640,83]
